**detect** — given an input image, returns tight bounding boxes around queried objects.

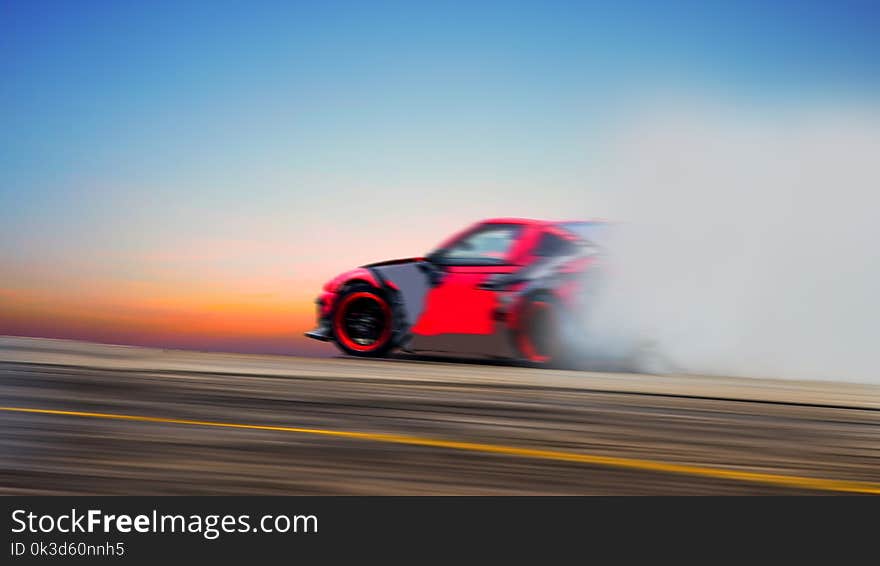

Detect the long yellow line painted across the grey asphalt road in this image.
[0,407,880,495]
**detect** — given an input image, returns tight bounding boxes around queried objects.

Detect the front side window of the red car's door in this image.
[430,224,522,265]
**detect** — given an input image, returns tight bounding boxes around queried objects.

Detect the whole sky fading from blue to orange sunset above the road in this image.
[0,0,880,354]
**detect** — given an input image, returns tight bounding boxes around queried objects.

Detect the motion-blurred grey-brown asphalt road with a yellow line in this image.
[0,337,880,495]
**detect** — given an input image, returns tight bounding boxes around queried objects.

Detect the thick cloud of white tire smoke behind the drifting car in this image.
[576,102,880,382]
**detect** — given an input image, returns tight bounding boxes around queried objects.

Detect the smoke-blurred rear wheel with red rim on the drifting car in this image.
[513,294,563,366]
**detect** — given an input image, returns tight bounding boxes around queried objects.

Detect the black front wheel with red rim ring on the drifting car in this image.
[333,283,394,357]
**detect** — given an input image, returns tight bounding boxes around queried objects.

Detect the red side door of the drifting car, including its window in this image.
[412,223,532,355]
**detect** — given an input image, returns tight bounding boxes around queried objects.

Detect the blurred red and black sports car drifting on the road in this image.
[306,218,607,364]
